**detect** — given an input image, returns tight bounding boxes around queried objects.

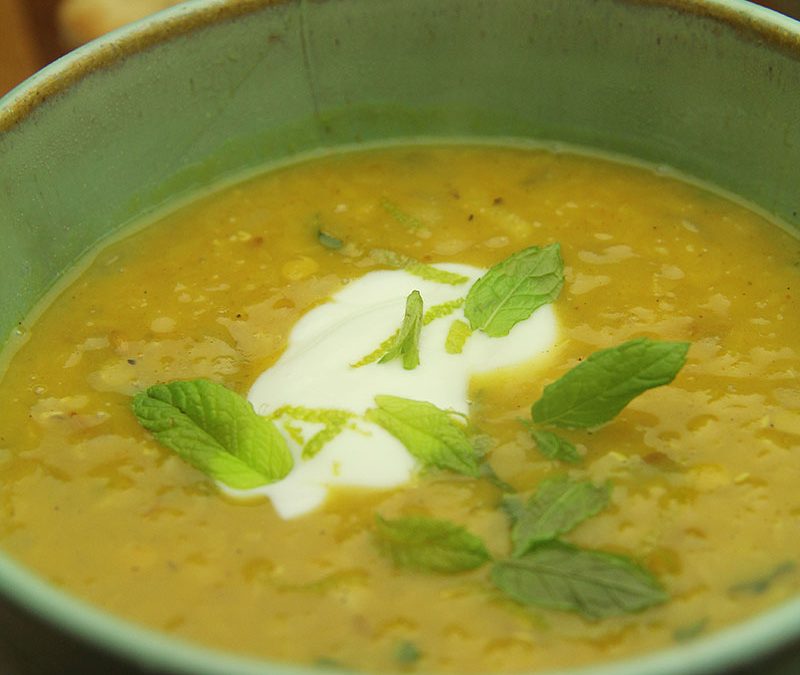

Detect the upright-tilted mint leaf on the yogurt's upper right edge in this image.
[464,244,564,337]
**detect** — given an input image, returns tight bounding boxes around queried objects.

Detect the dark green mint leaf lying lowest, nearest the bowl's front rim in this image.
[491,541,668,619]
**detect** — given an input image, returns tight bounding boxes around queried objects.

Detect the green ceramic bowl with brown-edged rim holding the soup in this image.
[0,0,800,675]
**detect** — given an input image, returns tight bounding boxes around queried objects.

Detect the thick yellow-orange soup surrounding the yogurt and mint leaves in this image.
[0,146,800,672]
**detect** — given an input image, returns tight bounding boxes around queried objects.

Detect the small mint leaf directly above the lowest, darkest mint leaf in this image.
[511,476,611,557]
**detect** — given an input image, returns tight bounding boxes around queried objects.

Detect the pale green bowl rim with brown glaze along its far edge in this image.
[0,0,800,675]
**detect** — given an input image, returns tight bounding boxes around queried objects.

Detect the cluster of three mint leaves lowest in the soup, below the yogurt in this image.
[376,478,668,619]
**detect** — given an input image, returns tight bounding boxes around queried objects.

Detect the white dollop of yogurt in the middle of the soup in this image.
[228,264,557,519]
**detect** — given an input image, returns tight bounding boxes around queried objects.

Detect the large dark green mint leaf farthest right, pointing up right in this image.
[531,338,689,428]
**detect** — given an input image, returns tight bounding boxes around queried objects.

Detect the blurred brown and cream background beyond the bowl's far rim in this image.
[0,0,800,95]
